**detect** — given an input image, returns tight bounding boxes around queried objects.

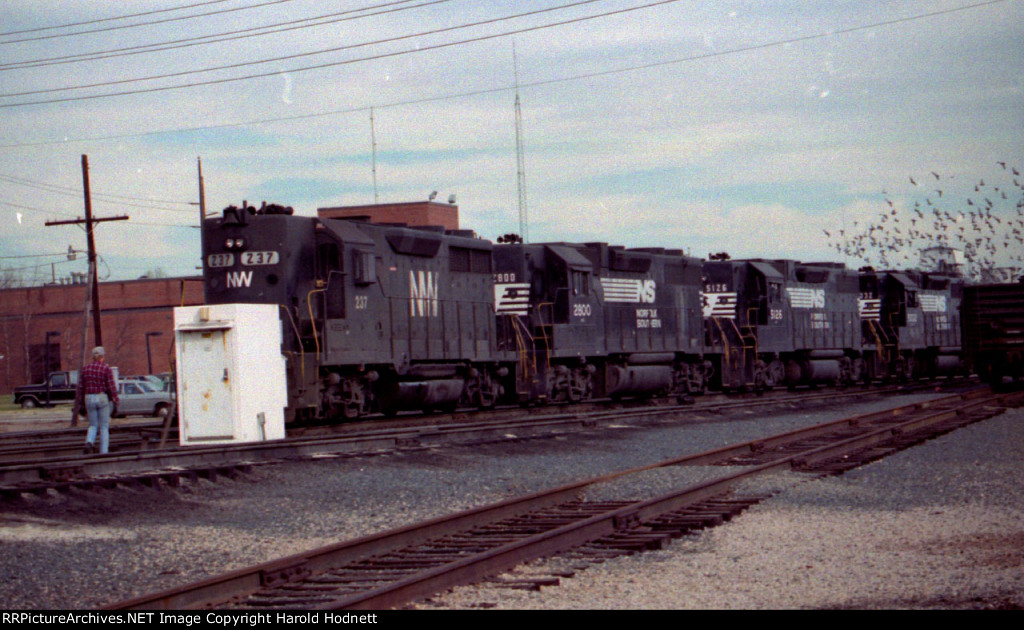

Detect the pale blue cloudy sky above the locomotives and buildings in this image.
[0,0,1024,284]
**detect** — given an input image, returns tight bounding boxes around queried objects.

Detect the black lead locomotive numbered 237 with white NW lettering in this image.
[204,206,515,420]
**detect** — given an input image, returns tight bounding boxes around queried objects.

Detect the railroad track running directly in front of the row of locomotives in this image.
[0,383,958,501]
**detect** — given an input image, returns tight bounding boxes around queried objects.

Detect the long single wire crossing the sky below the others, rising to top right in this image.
[0,0,1008,149]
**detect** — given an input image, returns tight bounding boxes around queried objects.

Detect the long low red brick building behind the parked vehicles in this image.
[0,277,203,394]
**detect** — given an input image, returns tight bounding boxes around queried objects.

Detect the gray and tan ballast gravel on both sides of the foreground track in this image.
[0,395,1024,610]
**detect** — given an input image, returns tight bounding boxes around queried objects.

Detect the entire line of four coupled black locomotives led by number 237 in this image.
[203,204,963,422]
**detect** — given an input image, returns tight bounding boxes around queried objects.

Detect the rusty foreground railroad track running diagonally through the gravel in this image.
[111,390,1024,610]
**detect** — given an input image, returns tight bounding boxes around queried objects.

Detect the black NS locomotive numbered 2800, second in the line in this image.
[494,238,709,403]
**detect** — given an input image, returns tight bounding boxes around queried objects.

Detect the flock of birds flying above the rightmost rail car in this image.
[824,162,1024,280]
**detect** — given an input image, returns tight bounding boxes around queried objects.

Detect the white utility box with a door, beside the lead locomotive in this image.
[174,304,288,446]
